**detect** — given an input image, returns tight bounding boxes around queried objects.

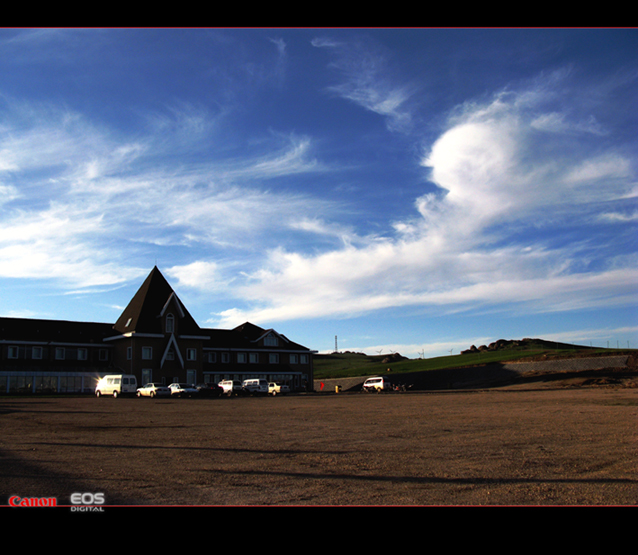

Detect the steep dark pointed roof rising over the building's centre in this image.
[113,266,200,334]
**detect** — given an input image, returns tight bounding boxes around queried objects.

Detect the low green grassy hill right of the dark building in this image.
[314,339,626,379]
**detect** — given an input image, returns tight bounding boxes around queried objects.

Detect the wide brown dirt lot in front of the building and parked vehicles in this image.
[0,374,638,510]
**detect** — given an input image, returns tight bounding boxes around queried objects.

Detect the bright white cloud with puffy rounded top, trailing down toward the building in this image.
[210,71,638,326]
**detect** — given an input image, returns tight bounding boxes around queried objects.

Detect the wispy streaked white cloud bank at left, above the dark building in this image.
[0,97,338,287]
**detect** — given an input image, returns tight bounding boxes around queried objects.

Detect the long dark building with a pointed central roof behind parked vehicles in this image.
[0,267,313,393]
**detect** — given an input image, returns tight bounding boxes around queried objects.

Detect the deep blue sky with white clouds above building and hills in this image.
[0,28,638,358]
